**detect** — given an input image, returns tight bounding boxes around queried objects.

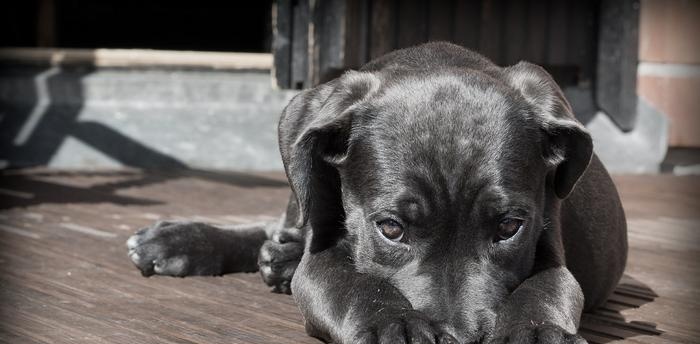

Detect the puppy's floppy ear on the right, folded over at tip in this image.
[505,62,593,199]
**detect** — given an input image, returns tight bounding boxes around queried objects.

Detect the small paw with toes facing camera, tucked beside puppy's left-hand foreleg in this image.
[258,228,304,294]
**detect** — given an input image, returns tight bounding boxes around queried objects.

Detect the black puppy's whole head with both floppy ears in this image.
[280,63,592,330]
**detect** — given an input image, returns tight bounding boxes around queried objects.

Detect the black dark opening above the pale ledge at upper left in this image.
[0,0,272,52]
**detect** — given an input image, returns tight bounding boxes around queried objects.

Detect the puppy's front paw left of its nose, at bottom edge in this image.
[348,309,459,344]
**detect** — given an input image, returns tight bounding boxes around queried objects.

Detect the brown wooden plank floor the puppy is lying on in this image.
[0,170,700,343]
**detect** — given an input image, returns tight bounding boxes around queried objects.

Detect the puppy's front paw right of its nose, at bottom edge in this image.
[487,324,587,344]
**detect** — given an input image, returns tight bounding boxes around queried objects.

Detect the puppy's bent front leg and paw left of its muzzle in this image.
[292,242,458,343]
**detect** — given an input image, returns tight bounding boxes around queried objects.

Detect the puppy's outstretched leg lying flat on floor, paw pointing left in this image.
[127,221,270,277]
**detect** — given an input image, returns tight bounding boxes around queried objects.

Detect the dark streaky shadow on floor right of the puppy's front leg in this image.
[579,274,663,344]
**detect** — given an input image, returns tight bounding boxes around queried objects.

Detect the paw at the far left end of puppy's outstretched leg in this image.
[126,221,223,277]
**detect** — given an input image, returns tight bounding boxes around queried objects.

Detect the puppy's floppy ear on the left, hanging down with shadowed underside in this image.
[279,71,379,232]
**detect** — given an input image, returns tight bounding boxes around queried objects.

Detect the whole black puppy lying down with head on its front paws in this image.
[128,43,627,343]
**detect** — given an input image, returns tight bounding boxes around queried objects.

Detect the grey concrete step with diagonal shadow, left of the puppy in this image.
[0,67,296,170]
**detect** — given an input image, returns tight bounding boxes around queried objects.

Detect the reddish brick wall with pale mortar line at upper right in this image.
[637,0,700,147]
